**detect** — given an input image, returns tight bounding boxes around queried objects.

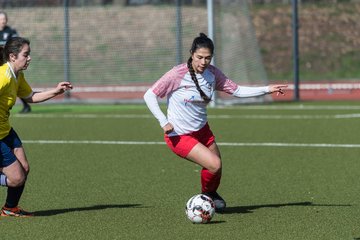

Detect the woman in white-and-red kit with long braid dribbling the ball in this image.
[144,33,287,211]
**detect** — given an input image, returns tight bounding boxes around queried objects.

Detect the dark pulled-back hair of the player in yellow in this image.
[0,37,30,65]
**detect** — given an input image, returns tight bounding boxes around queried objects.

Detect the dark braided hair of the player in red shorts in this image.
[187,33,214,103]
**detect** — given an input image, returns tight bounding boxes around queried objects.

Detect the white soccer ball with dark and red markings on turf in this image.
[185,194,215,223]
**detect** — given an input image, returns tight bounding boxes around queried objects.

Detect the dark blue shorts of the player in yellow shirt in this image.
[0,128,22,168]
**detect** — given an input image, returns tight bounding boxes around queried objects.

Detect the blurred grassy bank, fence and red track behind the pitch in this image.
[0,0,360,104]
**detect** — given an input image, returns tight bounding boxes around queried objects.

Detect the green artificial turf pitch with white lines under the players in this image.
[0,102,360,240]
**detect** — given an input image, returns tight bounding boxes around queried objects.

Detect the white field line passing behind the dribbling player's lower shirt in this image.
[14,113,360,119]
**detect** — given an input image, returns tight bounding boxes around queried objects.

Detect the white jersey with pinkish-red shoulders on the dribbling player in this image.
[144,63,269,136]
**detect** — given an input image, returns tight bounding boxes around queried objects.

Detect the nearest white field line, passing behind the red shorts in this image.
[22,140,360,148]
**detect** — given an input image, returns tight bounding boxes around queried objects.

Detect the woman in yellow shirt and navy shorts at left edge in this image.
[0,37,72,217]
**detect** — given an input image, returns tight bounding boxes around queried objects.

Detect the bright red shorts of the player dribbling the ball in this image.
[164,123,215,158]
